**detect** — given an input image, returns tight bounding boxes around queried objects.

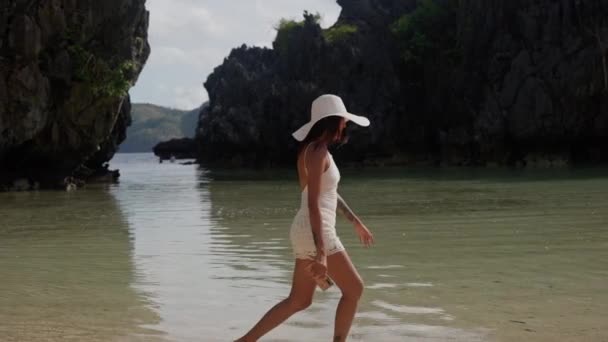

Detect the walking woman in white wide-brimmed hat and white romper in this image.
[237,95,373,342]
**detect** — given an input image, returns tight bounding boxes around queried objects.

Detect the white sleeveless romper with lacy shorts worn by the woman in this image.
[289,145,344,259]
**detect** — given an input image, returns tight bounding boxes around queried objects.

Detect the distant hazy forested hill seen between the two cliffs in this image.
[119,103,200,153]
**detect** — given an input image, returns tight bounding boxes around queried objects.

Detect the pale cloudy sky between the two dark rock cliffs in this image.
[130,0,340,109]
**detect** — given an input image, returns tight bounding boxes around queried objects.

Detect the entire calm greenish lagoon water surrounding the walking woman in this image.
[0,155,608,342]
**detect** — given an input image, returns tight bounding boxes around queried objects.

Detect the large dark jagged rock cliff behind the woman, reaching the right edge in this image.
[196,0,608,166]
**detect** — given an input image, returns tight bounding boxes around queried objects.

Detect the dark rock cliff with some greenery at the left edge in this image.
[0,0,150,188]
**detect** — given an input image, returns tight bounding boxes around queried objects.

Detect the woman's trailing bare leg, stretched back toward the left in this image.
[237,259,316,342]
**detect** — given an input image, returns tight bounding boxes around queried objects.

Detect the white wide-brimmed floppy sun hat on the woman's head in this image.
[292,94,369,141]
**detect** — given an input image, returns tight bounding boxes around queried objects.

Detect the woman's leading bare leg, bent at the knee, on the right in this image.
[327,251,363,342]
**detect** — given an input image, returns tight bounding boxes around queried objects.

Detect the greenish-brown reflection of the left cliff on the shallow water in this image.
[0,188,161,341]
